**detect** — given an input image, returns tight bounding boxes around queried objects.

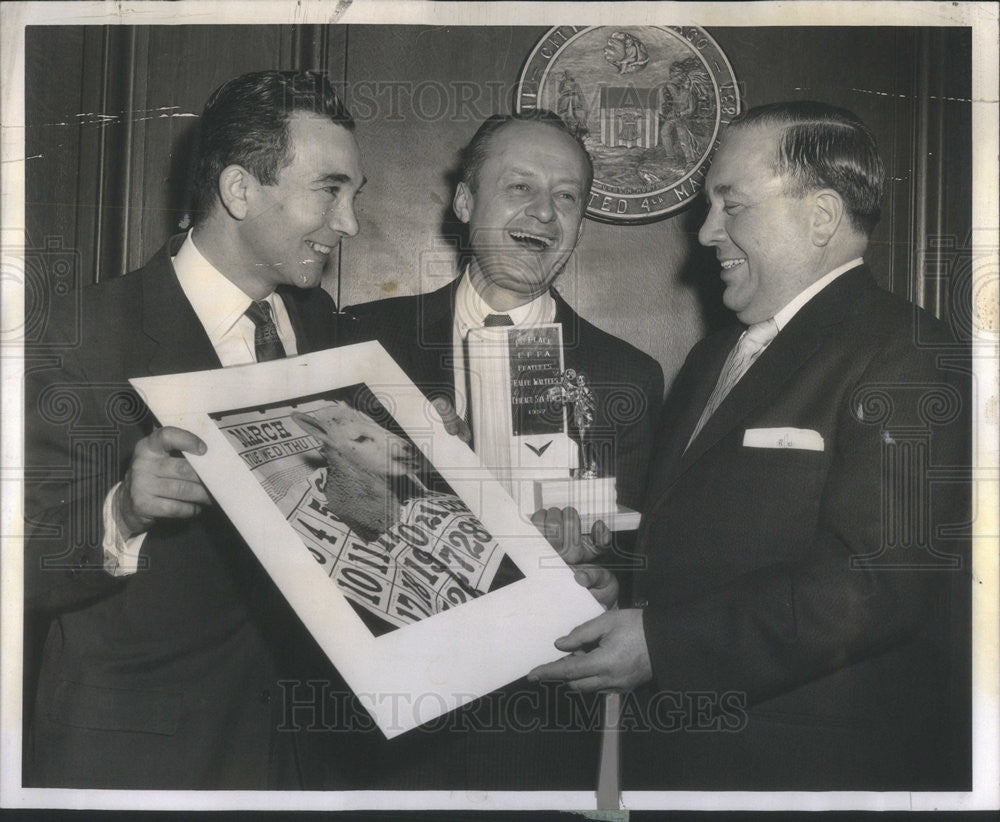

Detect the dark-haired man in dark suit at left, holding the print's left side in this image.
[25,71,364,789]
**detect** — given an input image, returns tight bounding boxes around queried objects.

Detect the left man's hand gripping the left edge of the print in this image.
[116,426,212,537]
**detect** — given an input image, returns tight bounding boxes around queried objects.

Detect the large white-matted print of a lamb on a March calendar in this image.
[132,342,602,738]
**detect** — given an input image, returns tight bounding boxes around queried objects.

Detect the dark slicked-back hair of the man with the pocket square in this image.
[729,100,885,235]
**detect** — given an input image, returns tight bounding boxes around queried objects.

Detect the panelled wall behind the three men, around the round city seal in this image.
[26,26,971,384]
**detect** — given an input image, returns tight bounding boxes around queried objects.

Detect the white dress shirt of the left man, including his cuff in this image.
[101,232,298,576]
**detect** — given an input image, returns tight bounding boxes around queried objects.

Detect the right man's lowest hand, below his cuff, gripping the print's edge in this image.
[528,608,653,691]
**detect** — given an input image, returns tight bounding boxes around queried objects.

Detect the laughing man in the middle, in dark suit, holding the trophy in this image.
[333,111,663,791]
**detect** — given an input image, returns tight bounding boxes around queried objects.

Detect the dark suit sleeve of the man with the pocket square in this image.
[644,330,971,703]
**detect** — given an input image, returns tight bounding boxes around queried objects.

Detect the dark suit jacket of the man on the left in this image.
[25,237,335,789]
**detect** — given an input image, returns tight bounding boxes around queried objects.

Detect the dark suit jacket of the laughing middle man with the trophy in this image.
[307,280,663,791]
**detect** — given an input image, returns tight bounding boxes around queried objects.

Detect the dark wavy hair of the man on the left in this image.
[194,71,354,216]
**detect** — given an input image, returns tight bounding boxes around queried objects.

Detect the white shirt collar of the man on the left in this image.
[173,231,275,346]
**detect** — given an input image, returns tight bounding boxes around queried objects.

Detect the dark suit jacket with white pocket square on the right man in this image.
[624,267,971,789]
